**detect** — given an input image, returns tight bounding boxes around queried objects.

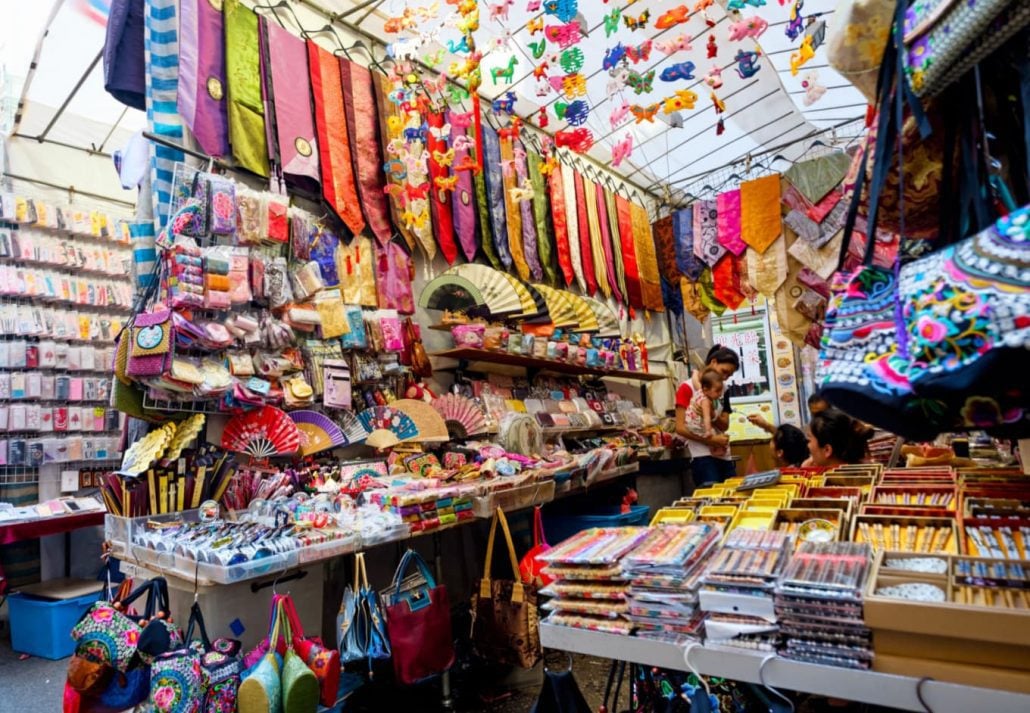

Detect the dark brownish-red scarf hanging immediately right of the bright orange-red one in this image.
[340,60,393,245]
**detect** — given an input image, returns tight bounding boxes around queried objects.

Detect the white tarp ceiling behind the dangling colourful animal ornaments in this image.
[0,0,865,202]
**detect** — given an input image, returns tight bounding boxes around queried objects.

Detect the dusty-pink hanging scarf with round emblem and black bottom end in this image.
[262,20,321,196]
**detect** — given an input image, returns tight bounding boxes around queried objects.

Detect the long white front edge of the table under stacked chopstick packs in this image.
[540,623,1030,713]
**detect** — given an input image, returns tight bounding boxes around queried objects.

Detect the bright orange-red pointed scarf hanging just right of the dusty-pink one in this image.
[308,39,365,235]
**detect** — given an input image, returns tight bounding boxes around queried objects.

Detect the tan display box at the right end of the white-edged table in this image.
[863,552,1030,685]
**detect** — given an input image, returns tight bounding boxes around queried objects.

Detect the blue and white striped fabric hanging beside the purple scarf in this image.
[145,0,184,226]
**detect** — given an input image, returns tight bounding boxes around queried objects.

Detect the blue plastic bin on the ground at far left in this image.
[7,592,97,660]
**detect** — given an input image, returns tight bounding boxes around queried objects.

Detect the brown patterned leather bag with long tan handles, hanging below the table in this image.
[472,508,542,669]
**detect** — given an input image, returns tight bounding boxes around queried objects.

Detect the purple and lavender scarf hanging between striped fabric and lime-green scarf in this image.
[178,0,227,158]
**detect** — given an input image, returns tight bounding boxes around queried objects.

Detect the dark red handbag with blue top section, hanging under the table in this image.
[383,549,454,685]
